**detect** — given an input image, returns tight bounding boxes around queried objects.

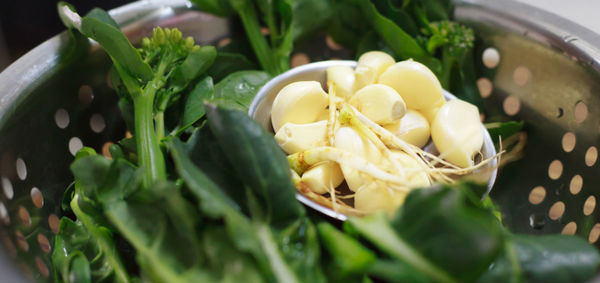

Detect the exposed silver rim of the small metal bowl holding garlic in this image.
[248,60,497,221]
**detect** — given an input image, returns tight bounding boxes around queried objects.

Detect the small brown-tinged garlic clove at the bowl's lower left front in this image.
[301,161,344,194]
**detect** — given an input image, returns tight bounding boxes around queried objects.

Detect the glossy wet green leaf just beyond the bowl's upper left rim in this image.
[213,71,271,111]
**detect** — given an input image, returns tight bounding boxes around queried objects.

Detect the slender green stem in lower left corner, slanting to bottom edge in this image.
[71,194,131,283]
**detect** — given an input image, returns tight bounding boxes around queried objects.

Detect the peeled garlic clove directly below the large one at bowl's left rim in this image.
[275,121,327,154]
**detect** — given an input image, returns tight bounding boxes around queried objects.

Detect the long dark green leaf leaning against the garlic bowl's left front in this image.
[204,103,304,224]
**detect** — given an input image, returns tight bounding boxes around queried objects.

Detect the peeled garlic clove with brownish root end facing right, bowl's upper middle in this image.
[349,84,406,125]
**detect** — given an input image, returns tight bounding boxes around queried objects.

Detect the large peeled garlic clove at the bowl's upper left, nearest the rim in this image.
[271,81,329,132]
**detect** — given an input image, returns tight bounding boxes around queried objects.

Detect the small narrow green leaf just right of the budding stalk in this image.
[181,76,214,130]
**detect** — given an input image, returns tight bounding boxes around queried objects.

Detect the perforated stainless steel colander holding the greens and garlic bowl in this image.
[0,0,600,282]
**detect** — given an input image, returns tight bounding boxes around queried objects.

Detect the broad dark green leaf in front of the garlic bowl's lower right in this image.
[394,184,504,281]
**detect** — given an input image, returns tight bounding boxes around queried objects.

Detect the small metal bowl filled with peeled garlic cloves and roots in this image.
[249,51,500,220]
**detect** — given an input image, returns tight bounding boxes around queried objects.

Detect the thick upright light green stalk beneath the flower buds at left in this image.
[133,82,167,188]
